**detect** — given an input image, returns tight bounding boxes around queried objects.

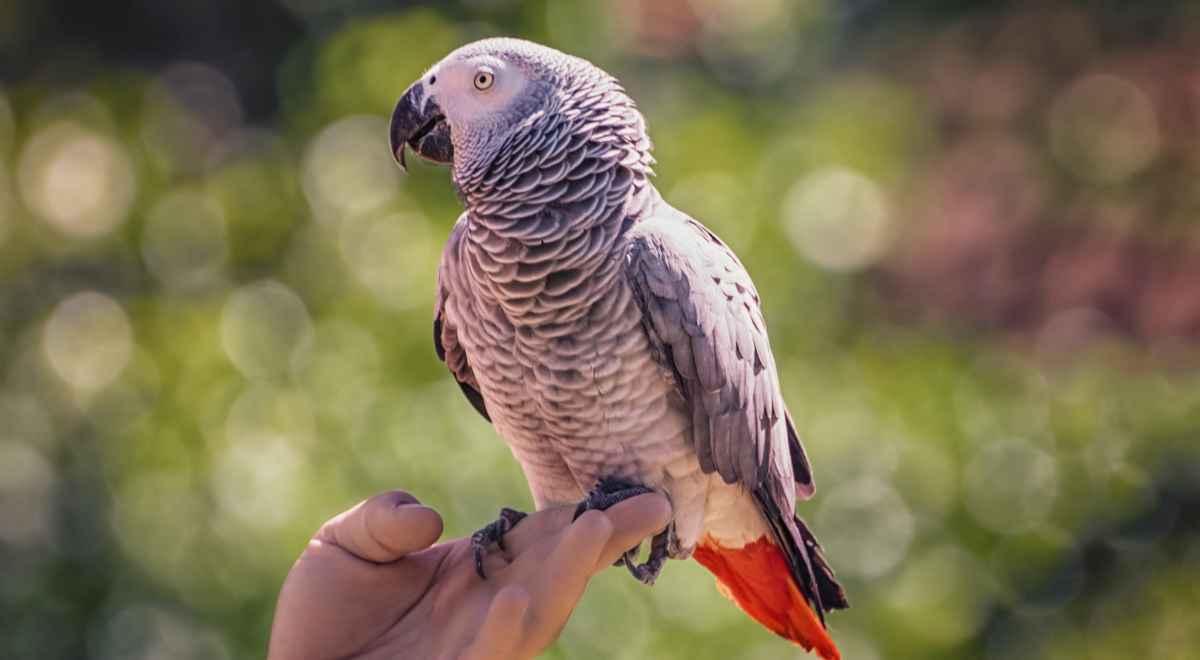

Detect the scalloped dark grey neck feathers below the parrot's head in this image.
[457,94,659,324]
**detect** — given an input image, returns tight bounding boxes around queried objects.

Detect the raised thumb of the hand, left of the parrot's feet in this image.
[317,491,443,564]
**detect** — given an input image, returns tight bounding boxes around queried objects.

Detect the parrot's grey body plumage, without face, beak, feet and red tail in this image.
[422,40,844,611]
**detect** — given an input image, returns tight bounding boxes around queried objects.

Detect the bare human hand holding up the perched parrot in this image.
[268,491,671,660]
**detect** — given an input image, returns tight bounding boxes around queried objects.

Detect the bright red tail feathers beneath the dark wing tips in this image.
[694,536,841,660]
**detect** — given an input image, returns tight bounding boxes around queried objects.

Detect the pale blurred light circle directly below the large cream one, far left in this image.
[42,292,133,394]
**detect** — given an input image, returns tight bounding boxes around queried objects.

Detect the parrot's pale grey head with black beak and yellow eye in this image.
[391,38,648,194]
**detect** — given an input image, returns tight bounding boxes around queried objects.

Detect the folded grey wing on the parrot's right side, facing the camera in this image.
[625,204,814,501]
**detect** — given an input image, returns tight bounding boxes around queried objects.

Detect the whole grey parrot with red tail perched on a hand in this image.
[390,37,848,660]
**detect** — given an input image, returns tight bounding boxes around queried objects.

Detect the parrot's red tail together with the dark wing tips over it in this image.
[692,493,850,660]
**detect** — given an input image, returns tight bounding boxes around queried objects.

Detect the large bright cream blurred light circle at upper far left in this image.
[18,121,136,238]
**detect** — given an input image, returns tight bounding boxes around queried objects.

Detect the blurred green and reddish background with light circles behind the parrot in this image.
[0,0,1200,660]
